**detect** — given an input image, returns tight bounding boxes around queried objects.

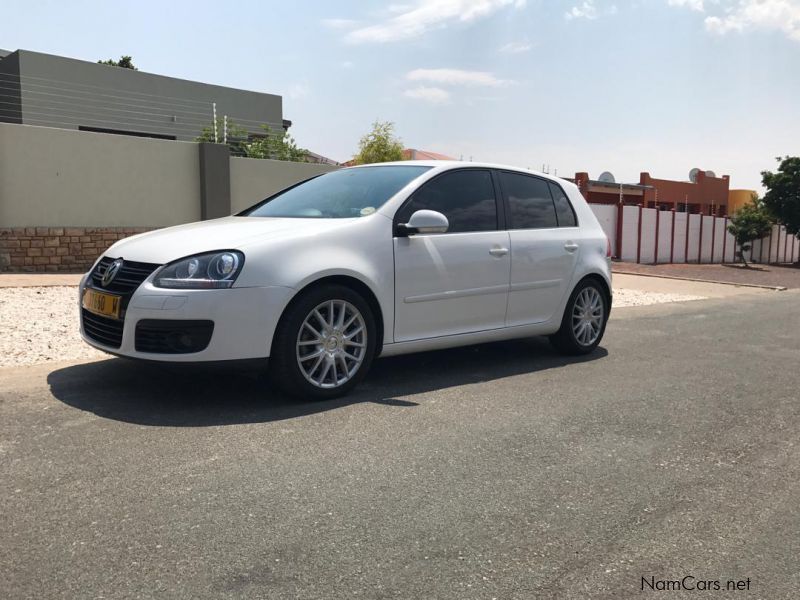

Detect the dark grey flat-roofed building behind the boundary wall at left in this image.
[0,50,291,141]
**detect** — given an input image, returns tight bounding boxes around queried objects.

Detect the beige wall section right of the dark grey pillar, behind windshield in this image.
[231,157,339,213]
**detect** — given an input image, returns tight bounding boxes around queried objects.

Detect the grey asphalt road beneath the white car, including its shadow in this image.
[0,291,800,600]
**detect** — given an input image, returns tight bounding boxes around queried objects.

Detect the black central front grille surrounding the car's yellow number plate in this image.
[81,256,161,348]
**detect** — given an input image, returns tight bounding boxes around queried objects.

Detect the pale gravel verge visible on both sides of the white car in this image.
[0,286,703,367]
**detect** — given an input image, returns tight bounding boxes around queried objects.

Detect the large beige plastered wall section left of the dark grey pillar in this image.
[0,123,200,227]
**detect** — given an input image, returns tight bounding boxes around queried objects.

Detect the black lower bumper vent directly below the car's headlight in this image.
[136,319,214,354]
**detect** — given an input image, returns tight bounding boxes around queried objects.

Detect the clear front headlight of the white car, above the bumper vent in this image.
[153,250,244,290]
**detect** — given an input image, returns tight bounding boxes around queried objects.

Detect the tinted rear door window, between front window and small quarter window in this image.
[500,171,558,229]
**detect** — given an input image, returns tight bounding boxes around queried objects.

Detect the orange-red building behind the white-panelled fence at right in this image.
[571,169,730,216]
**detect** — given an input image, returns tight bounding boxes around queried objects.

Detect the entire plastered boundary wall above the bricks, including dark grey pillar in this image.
[0,123,338,229]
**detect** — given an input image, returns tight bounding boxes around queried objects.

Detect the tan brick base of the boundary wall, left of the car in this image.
[0,227,152,273]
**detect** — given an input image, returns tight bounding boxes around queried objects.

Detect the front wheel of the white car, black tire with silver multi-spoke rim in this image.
[269,284,377,400]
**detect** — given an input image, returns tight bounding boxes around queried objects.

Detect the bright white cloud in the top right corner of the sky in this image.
[668,0,800,42]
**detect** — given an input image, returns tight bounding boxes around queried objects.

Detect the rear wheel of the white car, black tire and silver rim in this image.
[550,279,608,356]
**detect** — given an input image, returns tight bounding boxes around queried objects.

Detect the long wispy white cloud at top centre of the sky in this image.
[340,0,525,44]
